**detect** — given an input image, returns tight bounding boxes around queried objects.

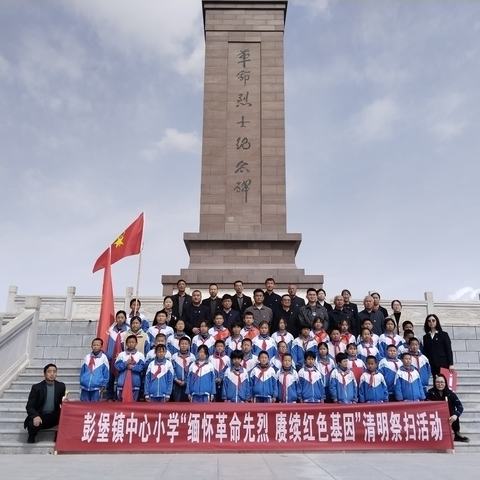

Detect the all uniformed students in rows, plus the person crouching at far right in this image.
[80,284,467,441]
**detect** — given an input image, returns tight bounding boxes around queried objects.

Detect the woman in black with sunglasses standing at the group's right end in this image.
[423,314,453,378]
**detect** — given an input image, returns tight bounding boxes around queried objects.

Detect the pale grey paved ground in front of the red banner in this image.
[0,453,480,480]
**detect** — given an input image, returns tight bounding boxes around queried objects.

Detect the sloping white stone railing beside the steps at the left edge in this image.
[0,297,40,395]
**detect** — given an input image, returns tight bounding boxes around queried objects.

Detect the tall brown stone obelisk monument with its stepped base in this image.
[162,0,323,295]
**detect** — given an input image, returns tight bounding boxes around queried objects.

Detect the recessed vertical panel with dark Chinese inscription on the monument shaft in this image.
[226,42,261,225]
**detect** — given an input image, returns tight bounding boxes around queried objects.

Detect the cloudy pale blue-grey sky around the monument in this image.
[0,0,480,310]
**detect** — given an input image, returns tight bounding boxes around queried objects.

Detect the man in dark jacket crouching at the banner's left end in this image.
[23,363,65,443]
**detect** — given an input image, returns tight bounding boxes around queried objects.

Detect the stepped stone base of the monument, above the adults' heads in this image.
[162,232,323,295]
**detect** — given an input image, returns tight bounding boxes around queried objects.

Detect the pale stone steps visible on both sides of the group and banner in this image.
[0,319,480,454]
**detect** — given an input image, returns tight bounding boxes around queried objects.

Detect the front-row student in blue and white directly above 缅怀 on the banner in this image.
[186,345,216,403]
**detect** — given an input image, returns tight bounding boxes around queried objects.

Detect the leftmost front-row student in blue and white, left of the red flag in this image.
[80,338,110,402]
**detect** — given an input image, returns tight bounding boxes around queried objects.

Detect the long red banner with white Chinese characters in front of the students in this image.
[56,402,453,453]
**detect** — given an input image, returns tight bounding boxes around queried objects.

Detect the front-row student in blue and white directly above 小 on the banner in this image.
[144,344,174,402]
